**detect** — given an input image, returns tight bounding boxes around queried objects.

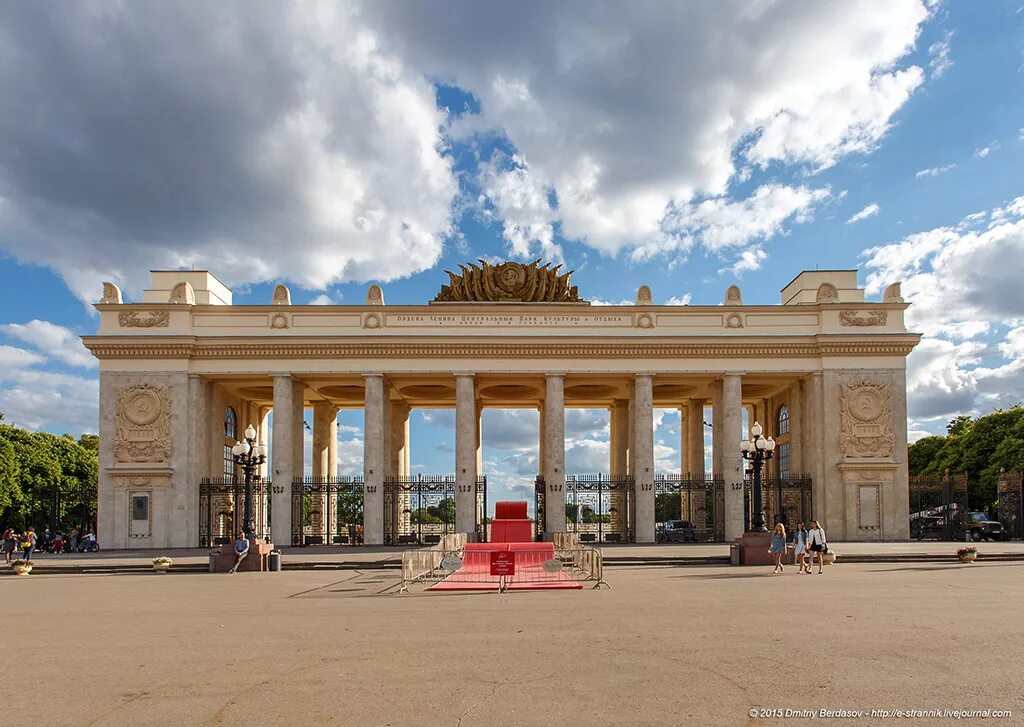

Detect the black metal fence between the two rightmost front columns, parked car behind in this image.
[654,474,725,543]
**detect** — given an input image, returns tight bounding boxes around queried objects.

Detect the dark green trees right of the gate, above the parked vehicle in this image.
[907,405,1024,509]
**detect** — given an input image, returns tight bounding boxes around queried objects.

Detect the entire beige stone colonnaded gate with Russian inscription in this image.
[84,263,920,548]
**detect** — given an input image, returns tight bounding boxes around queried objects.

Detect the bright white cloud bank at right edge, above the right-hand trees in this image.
[864,197,1024,429]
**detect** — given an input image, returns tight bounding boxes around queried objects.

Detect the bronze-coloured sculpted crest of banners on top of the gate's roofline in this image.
[432,259,587,303]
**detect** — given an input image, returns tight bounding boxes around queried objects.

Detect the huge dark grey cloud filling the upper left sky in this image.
[0,2,458,300]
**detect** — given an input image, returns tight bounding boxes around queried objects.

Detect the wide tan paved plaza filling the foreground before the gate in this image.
[0,561,1024,727]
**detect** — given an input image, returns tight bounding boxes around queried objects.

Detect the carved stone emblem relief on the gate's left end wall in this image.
[114,384,171,462]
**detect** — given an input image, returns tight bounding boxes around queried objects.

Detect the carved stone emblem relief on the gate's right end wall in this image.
[839,381,896,457]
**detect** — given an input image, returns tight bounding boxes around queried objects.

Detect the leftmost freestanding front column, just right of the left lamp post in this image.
[270,374,302,546]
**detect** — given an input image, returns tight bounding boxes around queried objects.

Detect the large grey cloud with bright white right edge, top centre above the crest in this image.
[364,0,928,258]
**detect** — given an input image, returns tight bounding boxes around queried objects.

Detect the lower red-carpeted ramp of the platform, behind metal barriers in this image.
[428,543,583,591]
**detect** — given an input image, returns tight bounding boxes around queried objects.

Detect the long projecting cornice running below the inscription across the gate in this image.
[83,334,921,360]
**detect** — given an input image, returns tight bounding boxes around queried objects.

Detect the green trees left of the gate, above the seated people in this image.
[0,424,99,529]
